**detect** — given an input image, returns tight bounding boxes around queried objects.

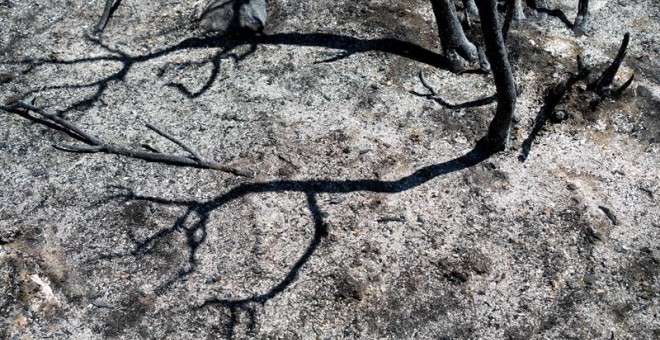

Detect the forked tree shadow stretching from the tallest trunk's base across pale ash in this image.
[99,142,492,338]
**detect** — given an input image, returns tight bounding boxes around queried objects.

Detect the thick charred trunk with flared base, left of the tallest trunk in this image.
[431,0,478,71]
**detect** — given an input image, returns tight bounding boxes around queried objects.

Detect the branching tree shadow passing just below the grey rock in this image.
[0,32,451,115]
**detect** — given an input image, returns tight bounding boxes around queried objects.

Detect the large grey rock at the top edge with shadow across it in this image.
[199,0,267,34]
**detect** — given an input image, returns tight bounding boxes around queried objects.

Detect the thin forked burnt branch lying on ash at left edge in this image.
[0,101,252,177]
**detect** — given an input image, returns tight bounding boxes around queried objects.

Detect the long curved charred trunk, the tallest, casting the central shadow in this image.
[476,0,516,151]
